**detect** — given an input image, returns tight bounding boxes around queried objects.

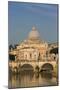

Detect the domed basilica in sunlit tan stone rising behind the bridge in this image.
[9,27,57,61]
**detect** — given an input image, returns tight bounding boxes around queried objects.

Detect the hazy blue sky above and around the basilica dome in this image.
[8,2,58,44]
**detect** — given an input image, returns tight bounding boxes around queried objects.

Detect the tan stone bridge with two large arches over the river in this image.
[9,60,56,71]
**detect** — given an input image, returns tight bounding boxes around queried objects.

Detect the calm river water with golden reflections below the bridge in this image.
[9,71,57,88]
